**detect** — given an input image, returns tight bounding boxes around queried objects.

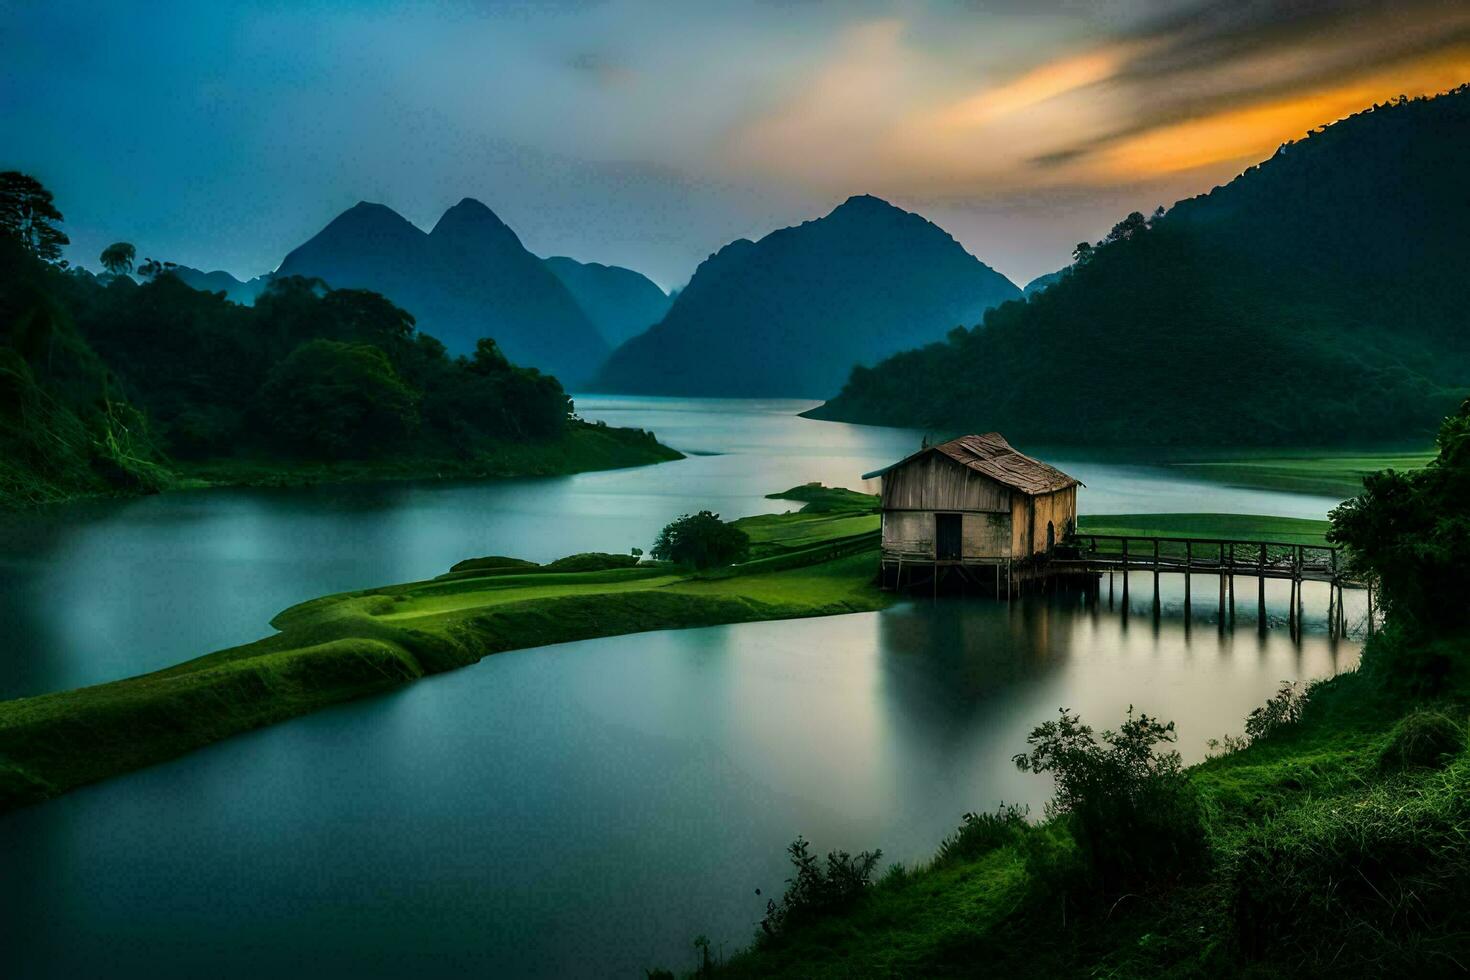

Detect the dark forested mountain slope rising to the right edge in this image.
[810,87,1470,445]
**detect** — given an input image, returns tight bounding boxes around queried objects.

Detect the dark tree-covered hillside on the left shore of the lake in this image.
[0,182,678,507]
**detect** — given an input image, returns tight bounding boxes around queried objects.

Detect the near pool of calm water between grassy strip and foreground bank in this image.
[0,573,1357,977]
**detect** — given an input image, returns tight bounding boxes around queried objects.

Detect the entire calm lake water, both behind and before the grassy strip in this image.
[0,398,1357,977]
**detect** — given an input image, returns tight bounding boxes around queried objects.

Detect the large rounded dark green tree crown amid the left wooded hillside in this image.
[260,339,419,458]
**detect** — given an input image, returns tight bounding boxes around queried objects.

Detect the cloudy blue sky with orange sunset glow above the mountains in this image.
[0,0,1470,288]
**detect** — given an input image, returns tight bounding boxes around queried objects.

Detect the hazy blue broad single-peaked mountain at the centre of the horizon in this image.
[592,195,1020,397]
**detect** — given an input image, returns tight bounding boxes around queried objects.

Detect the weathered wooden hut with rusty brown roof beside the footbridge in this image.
[866,432,1080,572]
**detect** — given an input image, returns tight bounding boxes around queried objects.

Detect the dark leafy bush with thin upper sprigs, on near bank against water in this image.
[1014,708,1208,893]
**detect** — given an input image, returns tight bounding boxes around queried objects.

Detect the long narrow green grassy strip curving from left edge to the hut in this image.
[0,481,886,810]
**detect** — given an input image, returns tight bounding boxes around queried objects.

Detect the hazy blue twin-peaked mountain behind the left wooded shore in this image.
[276,198,609,385]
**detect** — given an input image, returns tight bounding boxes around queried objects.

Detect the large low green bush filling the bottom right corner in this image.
[1229,765,1470,976]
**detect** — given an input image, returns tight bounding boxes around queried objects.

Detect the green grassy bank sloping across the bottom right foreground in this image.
[714,635,1470,977]
